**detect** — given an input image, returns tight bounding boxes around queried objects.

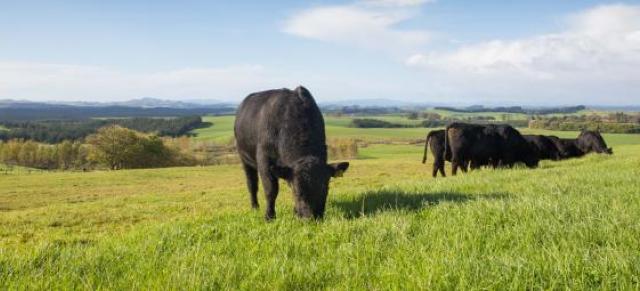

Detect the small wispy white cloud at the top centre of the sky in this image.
[284,0,429,52]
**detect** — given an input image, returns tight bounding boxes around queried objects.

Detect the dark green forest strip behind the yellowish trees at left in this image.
[0,116,207,144]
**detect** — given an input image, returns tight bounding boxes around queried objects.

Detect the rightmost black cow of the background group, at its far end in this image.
[554,130,613,159]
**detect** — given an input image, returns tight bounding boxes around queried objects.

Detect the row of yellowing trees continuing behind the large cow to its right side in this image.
[0,125,358,171]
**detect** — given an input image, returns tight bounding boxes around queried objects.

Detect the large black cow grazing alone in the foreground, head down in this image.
[234,87,349,220]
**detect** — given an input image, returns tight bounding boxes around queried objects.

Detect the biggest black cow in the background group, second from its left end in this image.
[445,123,539,175]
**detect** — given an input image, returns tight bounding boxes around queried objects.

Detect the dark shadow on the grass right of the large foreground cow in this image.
[333,190,509,219]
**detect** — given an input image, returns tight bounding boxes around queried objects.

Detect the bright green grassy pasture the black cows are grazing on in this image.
[0,117,640,290]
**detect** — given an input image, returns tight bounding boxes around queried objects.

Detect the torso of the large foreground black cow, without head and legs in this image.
[234,87,326,165]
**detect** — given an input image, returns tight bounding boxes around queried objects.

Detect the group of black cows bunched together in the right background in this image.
[422,123,613,177]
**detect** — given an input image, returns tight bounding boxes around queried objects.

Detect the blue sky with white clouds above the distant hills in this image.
[0,0,640,105]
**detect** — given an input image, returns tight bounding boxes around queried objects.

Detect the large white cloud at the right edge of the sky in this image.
[406,5,640,82]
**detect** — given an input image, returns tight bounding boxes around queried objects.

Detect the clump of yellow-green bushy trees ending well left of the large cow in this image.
[0,125,198,170]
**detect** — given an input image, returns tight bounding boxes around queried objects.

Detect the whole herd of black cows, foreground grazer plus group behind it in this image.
[234,87,612,220]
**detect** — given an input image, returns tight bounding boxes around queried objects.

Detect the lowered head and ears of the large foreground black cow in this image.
[272,157,349,218]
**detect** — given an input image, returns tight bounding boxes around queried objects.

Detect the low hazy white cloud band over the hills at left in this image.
[0,62,288,101]
